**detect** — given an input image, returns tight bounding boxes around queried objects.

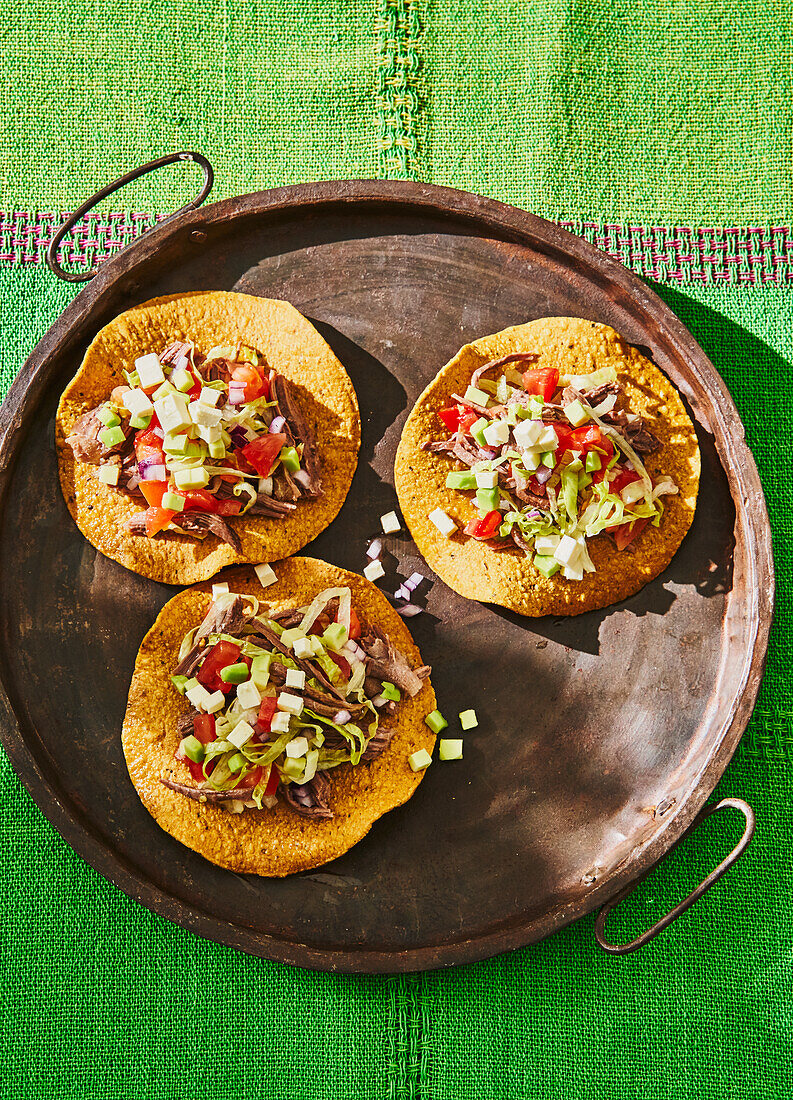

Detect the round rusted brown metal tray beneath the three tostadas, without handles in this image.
[0,182,773,971]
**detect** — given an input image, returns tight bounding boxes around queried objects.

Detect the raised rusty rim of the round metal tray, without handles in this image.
[0,179,774,974]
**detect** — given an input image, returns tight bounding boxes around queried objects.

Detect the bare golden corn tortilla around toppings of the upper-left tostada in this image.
[55,290,361,584]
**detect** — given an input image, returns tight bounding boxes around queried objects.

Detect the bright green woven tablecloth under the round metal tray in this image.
[0,0,793,1100]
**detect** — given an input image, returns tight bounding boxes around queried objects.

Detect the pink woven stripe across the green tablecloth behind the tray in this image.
[0,211,793,286]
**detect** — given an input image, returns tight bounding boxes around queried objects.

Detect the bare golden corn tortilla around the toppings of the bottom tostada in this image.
[121,558,436,878]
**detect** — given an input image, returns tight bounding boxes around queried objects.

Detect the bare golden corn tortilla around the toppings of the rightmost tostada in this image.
[395,317,701,616]
